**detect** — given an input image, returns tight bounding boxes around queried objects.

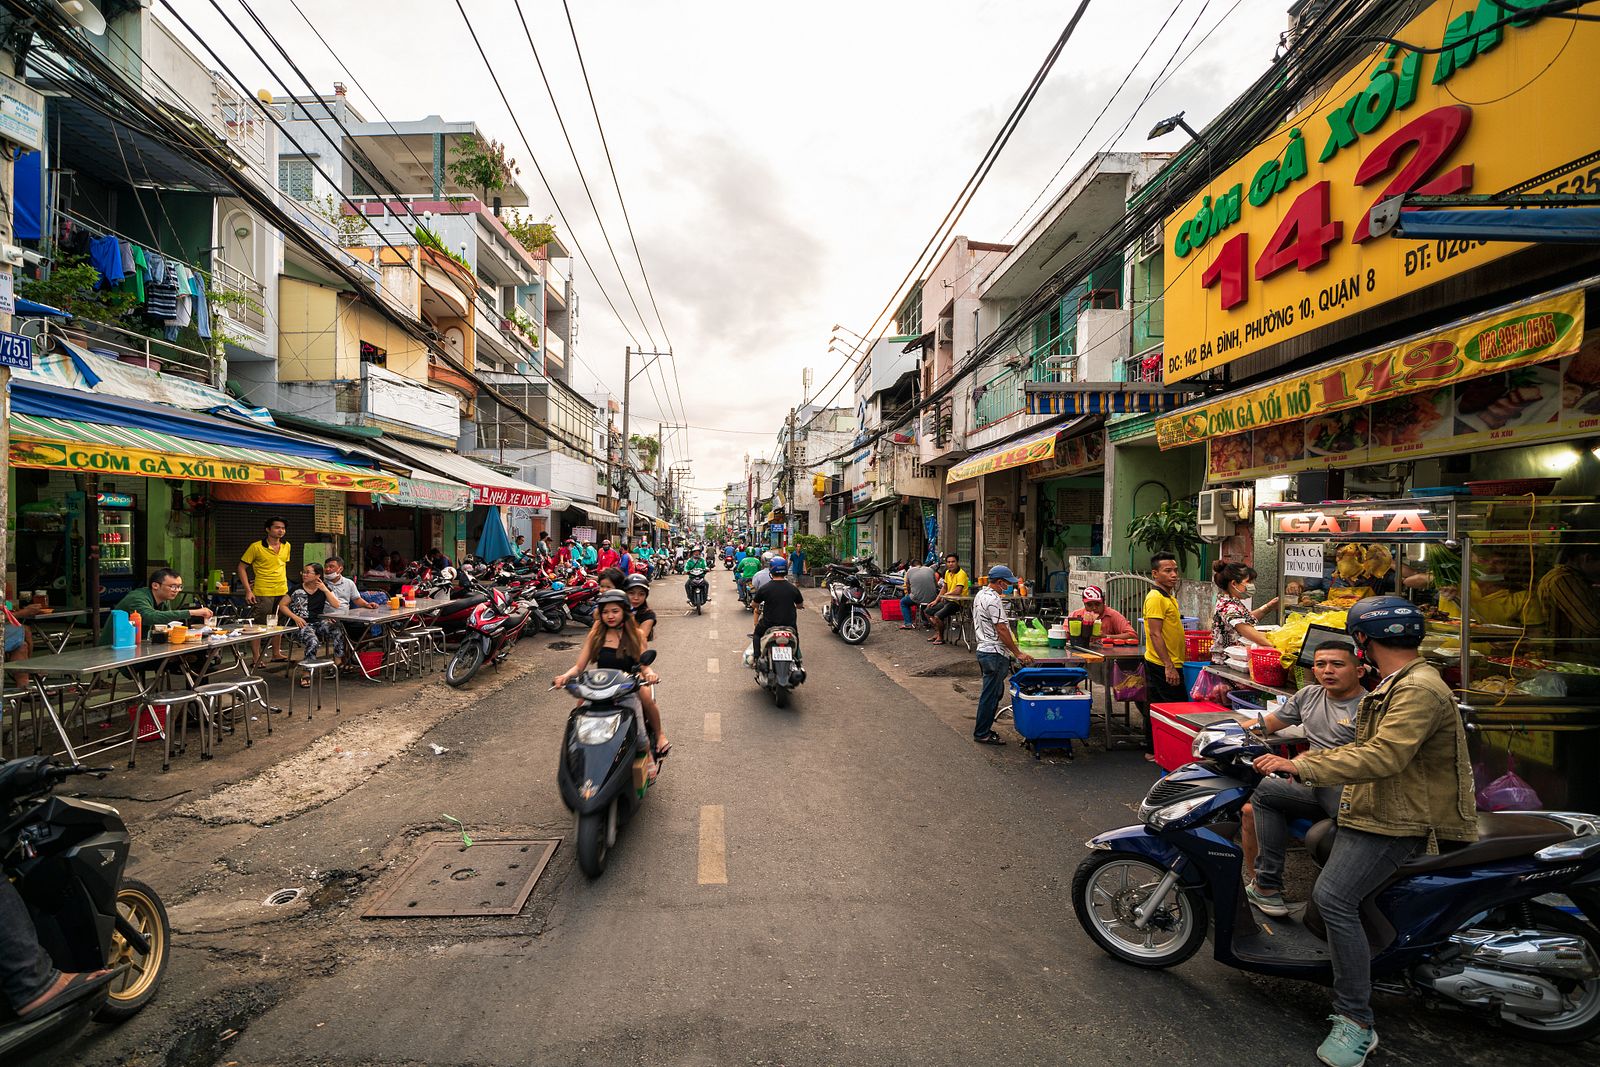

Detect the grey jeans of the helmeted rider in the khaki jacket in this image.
[1312,827,1427,1027]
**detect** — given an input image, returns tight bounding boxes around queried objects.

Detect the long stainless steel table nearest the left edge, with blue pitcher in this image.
[3,630,272,766]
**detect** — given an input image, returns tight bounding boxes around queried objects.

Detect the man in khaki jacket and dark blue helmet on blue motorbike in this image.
[1254,597,1478,1067]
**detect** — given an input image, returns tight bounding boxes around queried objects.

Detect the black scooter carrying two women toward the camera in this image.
[555,649,664,878]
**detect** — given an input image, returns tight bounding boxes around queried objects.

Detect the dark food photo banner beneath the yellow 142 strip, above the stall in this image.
[1206,336,1600,482]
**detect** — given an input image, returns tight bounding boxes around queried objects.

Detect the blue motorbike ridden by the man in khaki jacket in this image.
[1072,723,1600,1043]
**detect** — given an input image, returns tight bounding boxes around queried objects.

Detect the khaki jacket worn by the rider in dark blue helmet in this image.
[1294,659,1478,853]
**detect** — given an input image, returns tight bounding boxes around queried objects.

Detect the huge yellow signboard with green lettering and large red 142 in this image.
[1165,0,1600,382]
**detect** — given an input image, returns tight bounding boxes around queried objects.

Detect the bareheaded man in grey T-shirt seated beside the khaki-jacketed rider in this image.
[1240,641,1366,917]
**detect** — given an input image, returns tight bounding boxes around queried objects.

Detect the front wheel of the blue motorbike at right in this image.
[1072,853,1208,968]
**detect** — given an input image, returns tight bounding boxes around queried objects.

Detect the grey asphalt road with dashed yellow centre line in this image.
[31,574,1597,1067]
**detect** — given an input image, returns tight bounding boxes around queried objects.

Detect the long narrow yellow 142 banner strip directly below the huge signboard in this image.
[1155,291,1584,448]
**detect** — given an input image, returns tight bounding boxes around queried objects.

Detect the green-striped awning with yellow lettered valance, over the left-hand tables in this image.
[8,411,398,493]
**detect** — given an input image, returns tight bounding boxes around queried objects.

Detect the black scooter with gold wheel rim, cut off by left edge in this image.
[0,755,171,1064]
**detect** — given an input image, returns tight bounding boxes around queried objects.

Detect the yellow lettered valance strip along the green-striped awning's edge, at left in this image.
[8,437,400,493]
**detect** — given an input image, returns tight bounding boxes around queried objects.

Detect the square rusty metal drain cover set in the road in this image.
[365,840,558,918]
